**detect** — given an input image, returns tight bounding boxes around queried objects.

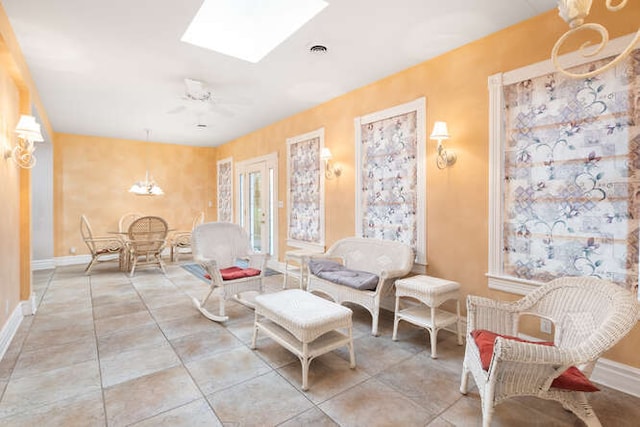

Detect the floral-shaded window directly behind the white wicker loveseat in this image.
[355,98,427,264]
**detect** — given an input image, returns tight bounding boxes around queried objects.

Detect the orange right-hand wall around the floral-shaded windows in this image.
[217,2,640,367]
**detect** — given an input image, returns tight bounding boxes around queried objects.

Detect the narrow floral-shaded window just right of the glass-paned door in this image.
[287,128,324,251]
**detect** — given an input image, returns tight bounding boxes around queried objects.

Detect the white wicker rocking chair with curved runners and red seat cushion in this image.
[191,222,267,322]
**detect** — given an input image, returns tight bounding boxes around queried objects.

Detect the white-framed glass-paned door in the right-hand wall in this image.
[236,153,278,259]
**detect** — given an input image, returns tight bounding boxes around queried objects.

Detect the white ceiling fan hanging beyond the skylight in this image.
[167,78,245,123]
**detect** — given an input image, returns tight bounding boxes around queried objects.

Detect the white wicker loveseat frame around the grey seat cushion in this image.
[307,237,414,335]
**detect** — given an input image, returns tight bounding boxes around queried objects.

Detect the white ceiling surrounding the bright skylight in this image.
[0,0,556,146]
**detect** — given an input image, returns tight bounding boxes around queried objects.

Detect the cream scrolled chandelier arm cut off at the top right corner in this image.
[551,0,640,78]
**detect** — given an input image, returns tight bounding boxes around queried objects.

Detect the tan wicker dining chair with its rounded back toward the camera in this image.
[127,216,169,277]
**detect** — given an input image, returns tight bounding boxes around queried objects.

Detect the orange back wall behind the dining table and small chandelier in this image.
[53,133,216,257]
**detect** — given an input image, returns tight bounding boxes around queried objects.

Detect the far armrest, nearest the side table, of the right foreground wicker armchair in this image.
[467,295,519,335]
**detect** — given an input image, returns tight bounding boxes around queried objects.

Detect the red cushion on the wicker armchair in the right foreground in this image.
[471,329,600,392]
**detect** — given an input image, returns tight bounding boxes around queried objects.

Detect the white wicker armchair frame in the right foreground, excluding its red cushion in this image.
[460,277,638,426]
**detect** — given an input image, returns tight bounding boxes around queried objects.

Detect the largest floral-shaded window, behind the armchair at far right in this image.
[489,36,640,293]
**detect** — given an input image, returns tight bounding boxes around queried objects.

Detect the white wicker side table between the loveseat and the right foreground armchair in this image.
[393,276,462,359]
